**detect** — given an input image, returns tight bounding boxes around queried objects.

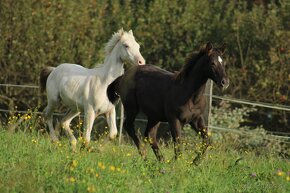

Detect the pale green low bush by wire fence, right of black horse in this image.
[211,103,289,154]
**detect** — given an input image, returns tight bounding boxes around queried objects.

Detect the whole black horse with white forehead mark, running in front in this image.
[107,43,229,163]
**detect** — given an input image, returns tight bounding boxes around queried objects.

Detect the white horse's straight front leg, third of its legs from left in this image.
[84,108,96,146]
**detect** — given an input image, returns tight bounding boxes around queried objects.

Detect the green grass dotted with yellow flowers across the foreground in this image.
[0,130,290,193]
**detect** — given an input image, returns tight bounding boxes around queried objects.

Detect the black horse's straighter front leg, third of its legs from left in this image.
[168,119,182,159]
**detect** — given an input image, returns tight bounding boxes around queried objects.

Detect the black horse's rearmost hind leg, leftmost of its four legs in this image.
[124,109,145,158]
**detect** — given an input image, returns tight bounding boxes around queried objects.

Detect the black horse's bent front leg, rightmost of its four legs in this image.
[189,117,210,165]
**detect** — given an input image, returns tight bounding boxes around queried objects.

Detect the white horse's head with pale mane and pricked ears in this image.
[106,29,145,65]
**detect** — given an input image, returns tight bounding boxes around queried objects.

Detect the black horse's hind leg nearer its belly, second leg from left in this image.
[145,119,164,162]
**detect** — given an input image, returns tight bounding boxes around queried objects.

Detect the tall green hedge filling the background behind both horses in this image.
[0,0,290,130]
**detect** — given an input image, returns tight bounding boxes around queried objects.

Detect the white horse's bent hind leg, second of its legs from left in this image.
[61,110,80,151]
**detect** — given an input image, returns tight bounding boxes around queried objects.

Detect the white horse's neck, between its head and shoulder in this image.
[103,48,124,84]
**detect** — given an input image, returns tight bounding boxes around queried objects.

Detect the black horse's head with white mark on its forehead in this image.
[203,42,230,90]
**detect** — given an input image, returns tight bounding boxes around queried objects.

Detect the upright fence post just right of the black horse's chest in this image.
[203,80,213,127]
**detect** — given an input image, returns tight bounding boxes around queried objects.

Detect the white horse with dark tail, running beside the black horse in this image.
[40,29,145,150]
